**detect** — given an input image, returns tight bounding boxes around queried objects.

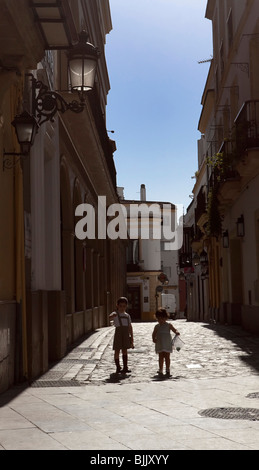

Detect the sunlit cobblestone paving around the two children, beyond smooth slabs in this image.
[33,320,259,386]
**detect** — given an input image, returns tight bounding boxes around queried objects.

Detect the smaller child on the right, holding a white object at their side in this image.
[152,308,180,377]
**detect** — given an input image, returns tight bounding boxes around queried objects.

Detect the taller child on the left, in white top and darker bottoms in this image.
[110,297,134,374]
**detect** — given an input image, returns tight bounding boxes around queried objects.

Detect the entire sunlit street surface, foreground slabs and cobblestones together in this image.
[0,320,259,452]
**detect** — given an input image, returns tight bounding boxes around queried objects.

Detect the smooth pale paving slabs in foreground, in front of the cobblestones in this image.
[0,375,259,450]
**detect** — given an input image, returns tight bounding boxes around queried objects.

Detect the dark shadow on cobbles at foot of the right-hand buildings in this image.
[202,323,259,373]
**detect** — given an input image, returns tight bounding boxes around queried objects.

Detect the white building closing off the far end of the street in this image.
[119,185,181,321]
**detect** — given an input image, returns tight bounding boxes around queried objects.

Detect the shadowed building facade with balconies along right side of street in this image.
[184,0,259,332]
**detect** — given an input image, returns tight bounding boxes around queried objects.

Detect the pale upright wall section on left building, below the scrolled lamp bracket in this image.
[30,117,61,290]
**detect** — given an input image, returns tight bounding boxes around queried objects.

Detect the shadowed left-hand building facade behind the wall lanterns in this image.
[0,0,126,391]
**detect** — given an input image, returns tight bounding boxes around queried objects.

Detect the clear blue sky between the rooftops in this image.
[106,0,212,211]
